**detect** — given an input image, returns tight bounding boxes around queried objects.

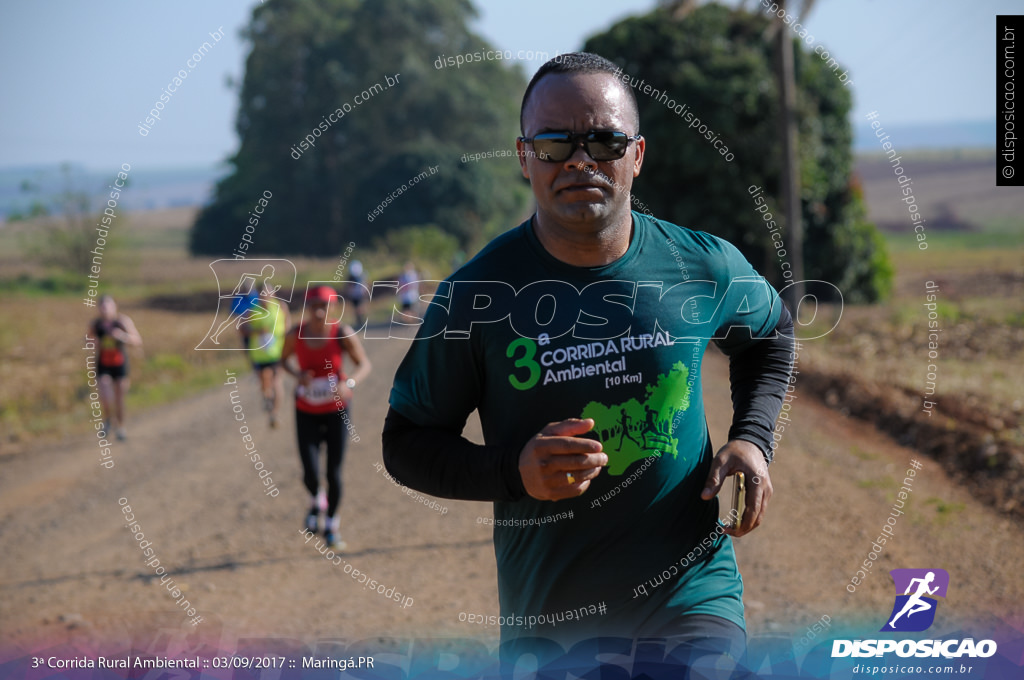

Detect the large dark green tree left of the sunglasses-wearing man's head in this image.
[191,0,527,257]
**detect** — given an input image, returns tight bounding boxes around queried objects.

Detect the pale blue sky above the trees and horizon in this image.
[0,0,1007,169]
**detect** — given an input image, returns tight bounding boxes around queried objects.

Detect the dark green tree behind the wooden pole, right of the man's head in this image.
[585,4,892,302]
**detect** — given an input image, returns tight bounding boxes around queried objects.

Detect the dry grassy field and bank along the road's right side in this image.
[798,218,1024,444]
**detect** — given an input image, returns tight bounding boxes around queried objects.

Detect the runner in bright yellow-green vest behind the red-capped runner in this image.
[239,289,288,428]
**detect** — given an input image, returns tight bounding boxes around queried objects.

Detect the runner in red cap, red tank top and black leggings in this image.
[281,286,372,552]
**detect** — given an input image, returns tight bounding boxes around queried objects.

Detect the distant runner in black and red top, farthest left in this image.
[87,295,142,441]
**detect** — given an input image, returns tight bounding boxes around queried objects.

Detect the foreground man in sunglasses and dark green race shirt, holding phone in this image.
[383,53,793,664]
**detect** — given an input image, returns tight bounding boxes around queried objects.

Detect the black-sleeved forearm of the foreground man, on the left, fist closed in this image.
[381,409,526,501]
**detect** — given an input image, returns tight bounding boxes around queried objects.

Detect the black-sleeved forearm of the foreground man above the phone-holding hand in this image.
[729,305,794,463]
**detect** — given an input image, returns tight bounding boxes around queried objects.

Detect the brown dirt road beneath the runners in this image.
[0,341,1024,648]
